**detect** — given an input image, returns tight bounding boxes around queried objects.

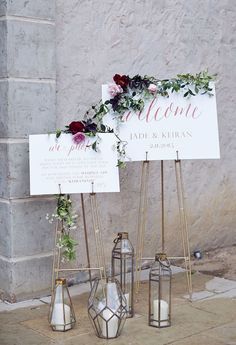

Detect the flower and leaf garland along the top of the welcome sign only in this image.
[105,71,215,117]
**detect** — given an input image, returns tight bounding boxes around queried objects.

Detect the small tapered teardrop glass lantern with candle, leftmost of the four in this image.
[49,278,76,332]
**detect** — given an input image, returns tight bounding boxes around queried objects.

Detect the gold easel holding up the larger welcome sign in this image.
[136,151,192,300]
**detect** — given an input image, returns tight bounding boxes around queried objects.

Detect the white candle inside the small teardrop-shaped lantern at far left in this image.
[51,303,71,331]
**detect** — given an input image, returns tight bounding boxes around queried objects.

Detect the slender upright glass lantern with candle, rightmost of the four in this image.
[148,253,172,328]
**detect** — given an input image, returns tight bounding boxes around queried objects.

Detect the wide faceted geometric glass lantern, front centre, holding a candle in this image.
[88,278,126,339]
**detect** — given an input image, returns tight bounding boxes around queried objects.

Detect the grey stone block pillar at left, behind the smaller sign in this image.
[0,0,56,301]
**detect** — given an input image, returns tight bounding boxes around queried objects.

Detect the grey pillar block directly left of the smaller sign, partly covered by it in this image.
[0,143,30,198]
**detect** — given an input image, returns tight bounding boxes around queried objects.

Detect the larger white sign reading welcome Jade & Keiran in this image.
[102,84,220,161]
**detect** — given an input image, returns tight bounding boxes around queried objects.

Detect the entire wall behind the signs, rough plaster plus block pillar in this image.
[0,0,236,301]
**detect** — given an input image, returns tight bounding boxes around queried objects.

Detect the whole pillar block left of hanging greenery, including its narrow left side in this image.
[0,198,56,258]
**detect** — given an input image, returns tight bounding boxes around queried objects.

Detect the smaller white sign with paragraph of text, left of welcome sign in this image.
[29,133,120,195]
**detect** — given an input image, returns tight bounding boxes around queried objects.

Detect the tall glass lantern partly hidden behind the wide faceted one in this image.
[111,232,134,317]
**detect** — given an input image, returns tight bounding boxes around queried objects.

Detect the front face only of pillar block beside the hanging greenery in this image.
[11,198,56,257]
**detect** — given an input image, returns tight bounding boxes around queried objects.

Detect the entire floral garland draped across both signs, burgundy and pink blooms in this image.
[56,71,215,166]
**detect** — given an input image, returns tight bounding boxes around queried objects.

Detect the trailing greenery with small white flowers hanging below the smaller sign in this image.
[46,194,78,261]
